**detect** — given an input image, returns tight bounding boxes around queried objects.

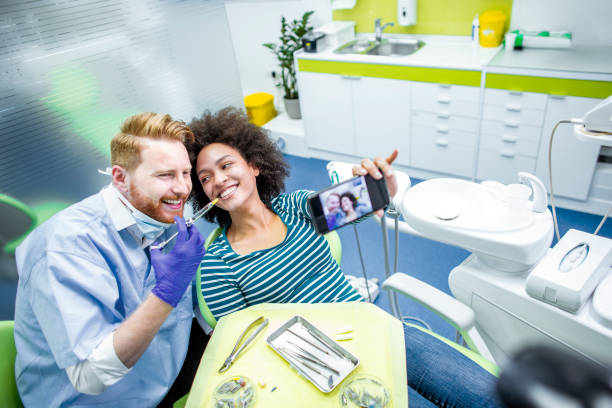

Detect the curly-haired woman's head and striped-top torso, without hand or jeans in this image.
[188,108,361,318]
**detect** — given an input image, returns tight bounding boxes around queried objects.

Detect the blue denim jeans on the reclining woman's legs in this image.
[404,325,503,408]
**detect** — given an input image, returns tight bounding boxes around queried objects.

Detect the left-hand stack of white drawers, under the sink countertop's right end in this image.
[410,82,480,177]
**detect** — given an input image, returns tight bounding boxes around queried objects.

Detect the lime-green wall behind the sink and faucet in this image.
[333,0,512,35]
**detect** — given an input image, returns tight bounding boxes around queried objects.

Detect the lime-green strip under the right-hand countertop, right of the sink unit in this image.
[485,74,612,98]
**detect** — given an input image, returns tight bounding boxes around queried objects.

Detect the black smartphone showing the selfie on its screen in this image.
[308,175,389,234]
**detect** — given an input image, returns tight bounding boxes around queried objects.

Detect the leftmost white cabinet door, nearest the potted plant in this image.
[298,72,355,154]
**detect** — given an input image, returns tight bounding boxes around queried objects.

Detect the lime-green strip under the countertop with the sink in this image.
[298,59,481,86]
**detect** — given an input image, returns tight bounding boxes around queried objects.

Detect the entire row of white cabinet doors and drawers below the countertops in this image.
[298,61,600,206]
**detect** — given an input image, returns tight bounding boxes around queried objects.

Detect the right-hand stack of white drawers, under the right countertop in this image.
[476,89,547,184]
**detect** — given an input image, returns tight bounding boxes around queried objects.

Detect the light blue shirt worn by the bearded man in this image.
[15,188,193,408]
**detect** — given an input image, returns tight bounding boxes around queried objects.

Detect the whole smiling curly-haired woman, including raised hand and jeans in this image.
[187,108,500,407]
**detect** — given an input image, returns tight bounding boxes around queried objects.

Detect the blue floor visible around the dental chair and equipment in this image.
[0,156,612,339]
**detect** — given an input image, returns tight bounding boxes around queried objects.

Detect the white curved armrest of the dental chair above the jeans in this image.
[382,272,495,362]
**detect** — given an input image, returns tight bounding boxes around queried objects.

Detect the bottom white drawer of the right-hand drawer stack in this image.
[476,149,536,184]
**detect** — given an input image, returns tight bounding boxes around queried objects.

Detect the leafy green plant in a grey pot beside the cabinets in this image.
[263,11,314,119]
